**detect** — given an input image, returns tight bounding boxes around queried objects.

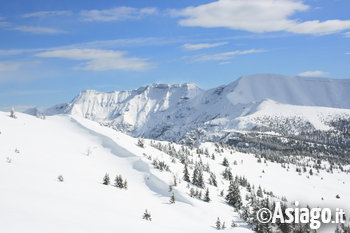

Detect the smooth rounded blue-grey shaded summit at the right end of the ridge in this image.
[227,74,350,108]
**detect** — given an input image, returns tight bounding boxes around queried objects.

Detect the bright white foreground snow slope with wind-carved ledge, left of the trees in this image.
[0,112,251,233]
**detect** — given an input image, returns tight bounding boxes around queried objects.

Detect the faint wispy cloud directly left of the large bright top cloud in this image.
[80,7,157,22]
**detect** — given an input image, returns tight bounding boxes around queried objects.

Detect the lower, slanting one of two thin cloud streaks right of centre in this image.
[187,49,266,62]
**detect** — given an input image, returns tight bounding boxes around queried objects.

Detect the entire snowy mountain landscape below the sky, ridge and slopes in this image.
[0,75,350,233]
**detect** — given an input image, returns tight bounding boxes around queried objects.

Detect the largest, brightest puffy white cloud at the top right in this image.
[172,0,350,34]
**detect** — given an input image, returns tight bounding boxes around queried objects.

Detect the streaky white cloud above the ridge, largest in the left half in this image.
[36,49,152,71]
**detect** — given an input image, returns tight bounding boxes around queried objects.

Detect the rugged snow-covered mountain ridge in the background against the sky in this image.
[47,74,350,141]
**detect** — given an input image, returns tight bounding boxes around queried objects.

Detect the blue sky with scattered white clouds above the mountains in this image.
[0,0,350,106]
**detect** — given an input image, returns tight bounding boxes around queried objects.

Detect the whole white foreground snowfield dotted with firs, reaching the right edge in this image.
[0,112,350,233]
